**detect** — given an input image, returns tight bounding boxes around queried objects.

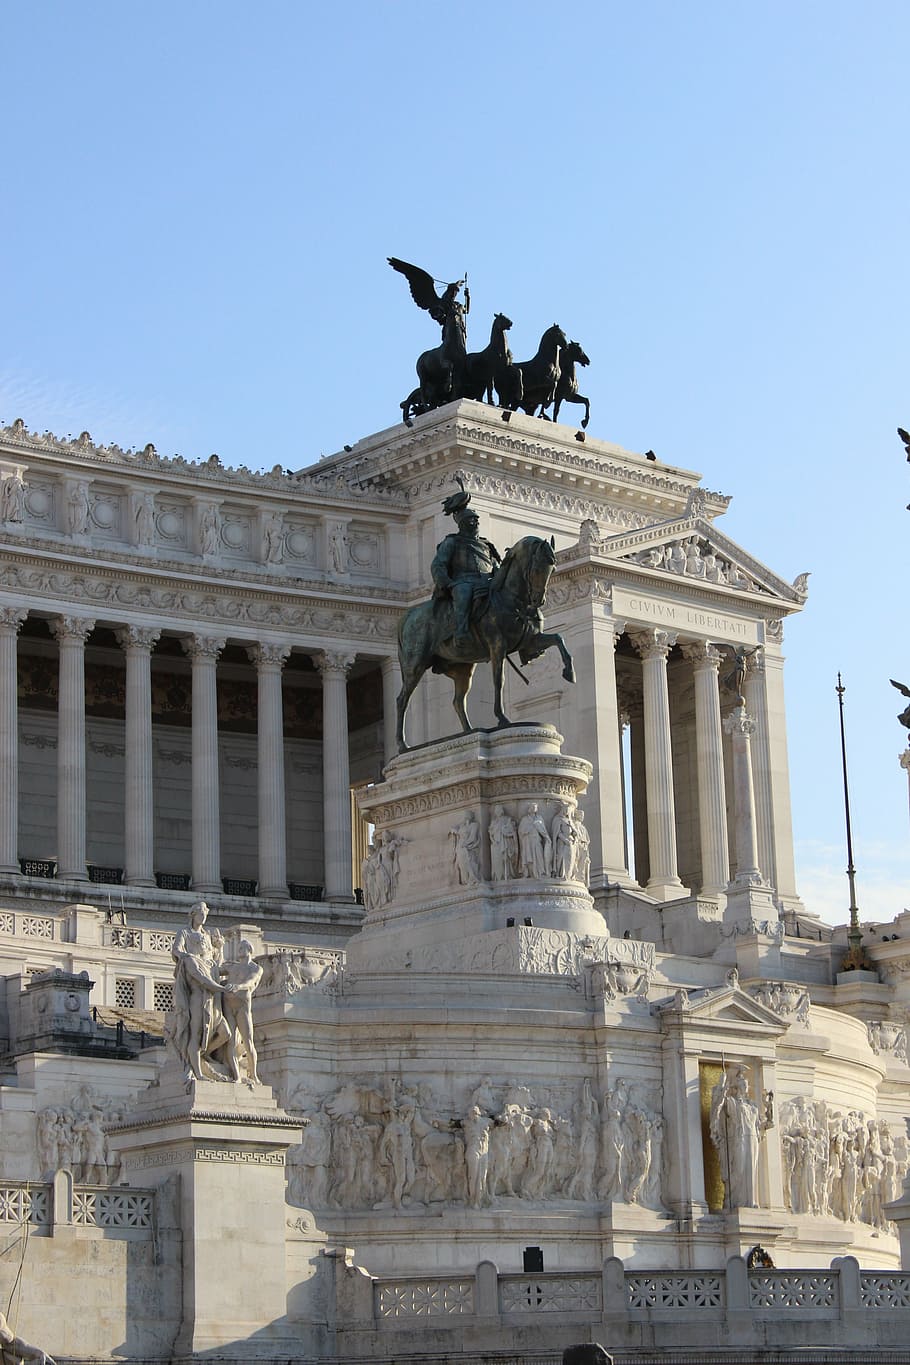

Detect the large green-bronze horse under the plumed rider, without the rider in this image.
[397,535,576,753]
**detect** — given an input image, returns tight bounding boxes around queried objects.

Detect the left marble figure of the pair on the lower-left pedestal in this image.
[169,901,231,1081]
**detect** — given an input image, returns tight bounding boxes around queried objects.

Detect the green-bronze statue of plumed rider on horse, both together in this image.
[397,487,574,753]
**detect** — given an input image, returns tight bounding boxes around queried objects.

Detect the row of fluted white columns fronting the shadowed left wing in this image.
[0,607,400,901]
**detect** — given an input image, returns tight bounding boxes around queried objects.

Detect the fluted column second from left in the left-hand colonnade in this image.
[50,616,94,882]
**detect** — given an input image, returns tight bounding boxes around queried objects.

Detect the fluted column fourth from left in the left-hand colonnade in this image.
[183,635,224,891]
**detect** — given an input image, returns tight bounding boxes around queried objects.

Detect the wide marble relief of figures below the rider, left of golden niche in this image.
[288,1077,663,1209]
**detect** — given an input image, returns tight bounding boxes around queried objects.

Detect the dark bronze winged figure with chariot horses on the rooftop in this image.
[389,257,591,427]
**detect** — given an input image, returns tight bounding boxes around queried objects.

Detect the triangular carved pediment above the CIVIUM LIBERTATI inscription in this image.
[599,516,808,606]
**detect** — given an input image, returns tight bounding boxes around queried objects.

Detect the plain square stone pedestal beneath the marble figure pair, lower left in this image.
[109,1059,300,1360]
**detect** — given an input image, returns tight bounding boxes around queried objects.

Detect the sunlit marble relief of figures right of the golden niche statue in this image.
[780,1096,910,1231]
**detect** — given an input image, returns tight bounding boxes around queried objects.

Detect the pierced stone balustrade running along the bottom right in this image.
[332,1256,910,1360]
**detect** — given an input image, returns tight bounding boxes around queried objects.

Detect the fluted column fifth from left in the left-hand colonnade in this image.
[247,644,291,900]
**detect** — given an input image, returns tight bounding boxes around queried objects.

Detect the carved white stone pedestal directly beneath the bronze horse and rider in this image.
[347,725,604,971]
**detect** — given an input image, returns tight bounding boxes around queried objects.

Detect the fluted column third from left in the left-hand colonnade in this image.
[117,625,161,886]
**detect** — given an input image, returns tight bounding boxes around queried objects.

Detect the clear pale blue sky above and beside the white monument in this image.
[0,0,910,920]
